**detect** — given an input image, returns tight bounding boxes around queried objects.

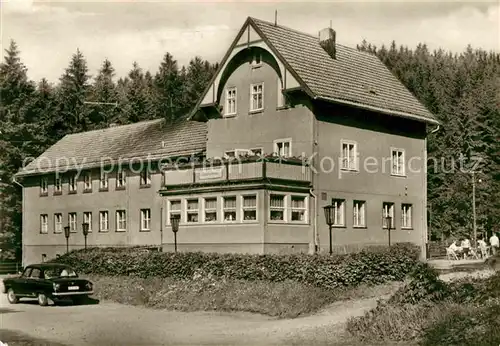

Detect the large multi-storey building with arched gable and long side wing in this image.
[16,18,438,263]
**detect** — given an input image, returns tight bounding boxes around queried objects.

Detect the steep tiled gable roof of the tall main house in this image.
[191,17,438,123]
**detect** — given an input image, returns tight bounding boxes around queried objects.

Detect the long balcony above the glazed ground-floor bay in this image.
[164,157,311,189]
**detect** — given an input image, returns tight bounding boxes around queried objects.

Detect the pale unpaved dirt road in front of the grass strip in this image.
[0,294,376,346]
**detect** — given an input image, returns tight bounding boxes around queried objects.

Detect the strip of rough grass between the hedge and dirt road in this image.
[89,274,400,318]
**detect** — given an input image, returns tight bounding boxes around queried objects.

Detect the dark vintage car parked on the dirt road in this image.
[3,263,94,306]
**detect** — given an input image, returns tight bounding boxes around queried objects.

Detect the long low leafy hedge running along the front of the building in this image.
[52,244,420,288]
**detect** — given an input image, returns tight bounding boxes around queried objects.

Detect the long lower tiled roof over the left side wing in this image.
[17,119,207,176]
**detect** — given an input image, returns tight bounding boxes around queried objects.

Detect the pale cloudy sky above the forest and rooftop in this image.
[0,0,500,82]
